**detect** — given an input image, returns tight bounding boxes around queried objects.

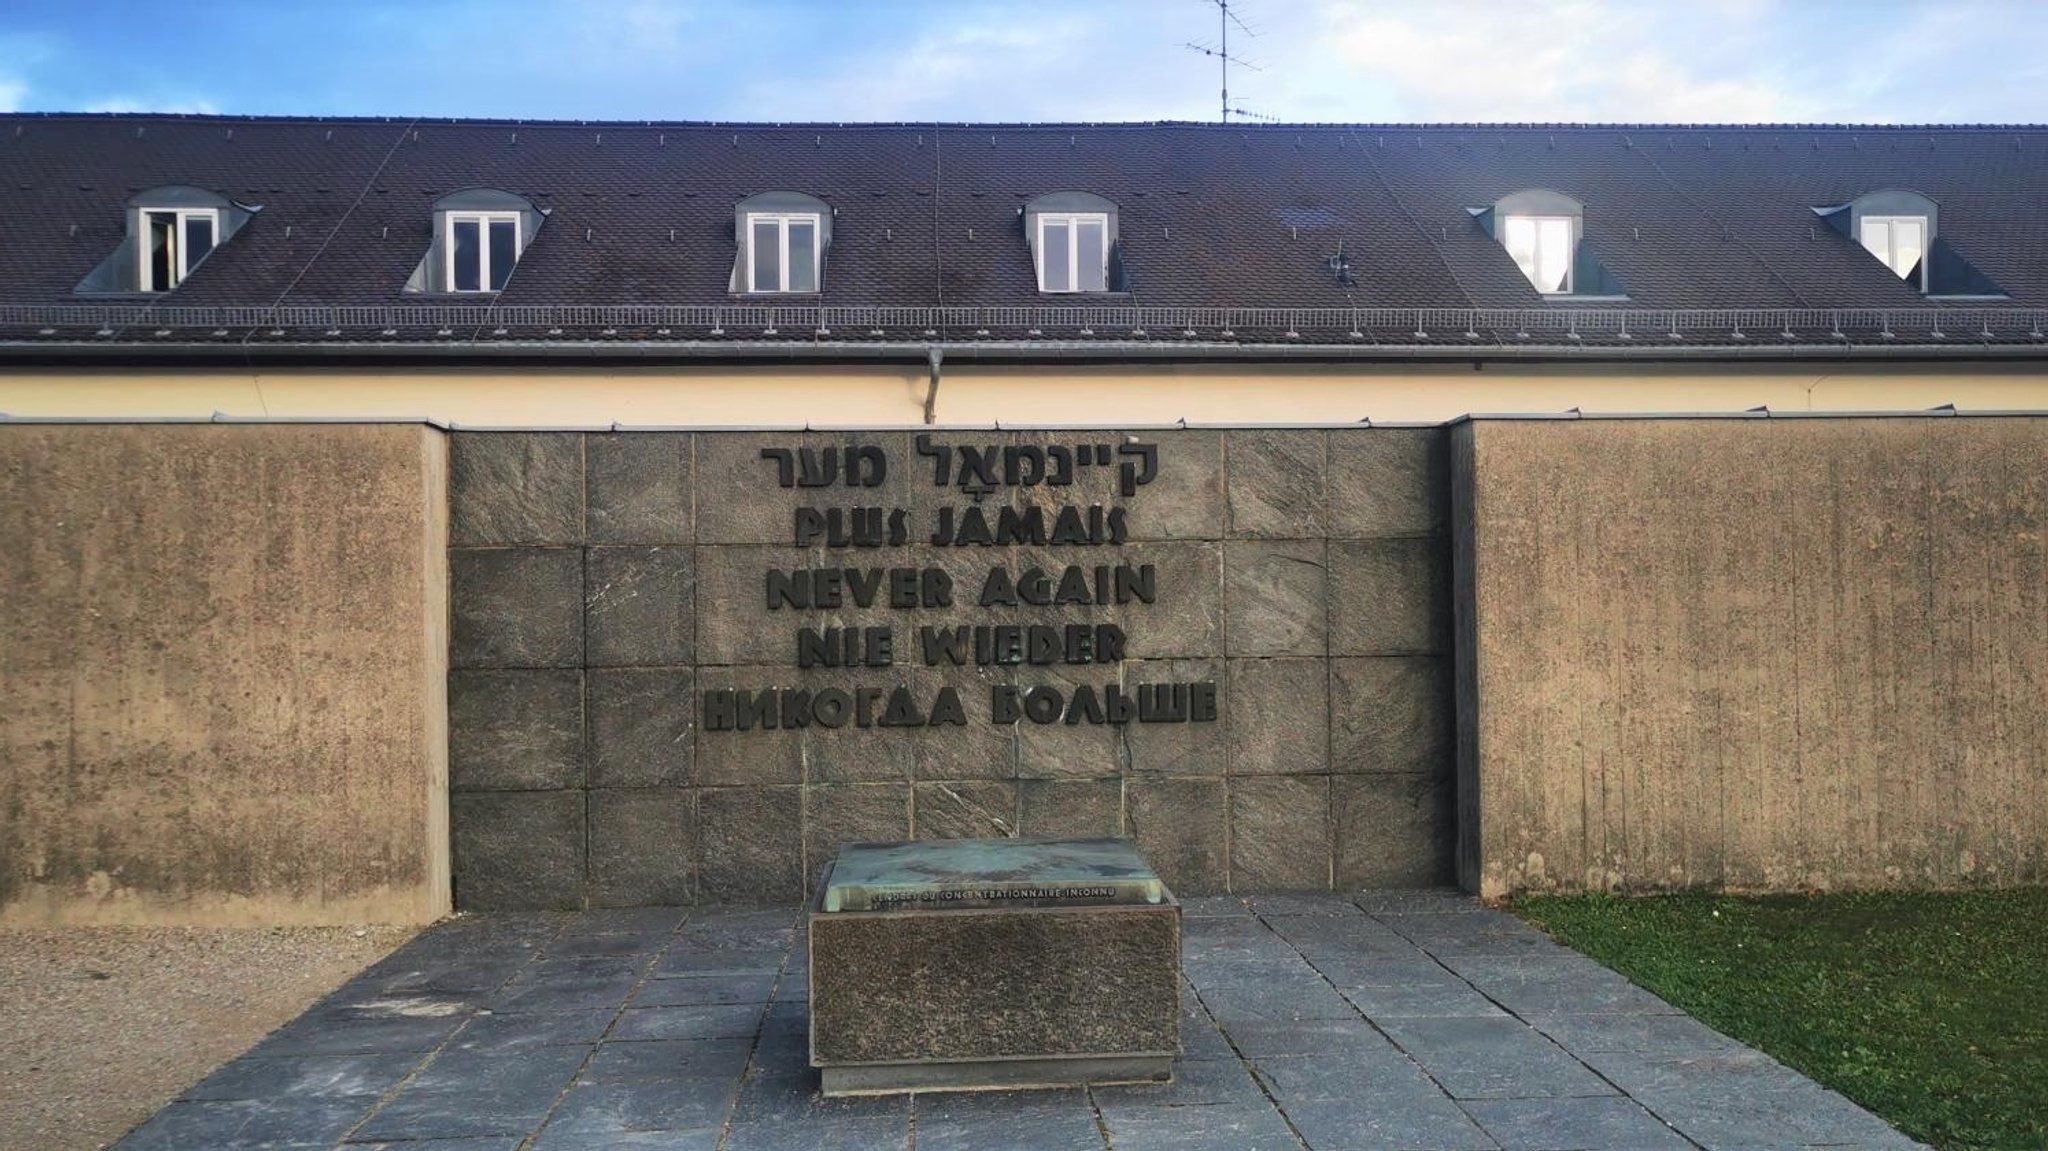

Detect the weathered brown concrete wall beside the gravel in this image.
[0,424,449,924]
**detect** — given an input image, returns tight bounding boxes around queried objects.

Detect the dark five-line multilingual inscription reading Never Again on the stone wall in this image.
[700,434,1219,733]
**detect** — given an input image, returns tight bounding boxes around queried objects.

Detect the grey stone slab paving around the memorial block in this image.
[121,893,1917,1151]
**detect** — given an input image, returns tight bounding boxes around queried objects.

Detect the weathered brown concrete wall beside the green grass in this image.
[1452,416,2048,895]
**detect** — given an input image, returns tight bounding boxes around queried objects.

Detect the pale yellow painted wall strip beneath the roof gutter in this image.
[0,365,2048,428]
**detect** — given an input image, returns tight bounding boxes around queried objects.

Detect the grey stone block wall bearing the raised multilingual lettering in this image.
[449,428,1454,909]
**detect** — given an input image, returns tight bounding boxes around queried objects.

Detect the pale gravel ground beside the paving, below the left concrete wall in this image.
[0,928,414,1151]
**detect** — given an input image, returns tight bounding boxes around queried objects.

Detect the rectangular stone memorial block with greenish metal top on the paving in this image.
[809,840,1182,1096]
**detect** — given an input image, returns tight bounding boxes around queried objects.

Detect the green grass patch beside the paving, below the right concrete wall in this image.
[1516,889,2048,1151]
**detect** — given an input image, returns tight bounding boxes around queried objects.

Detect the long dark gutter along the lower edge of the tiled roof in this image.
[0,340,2048,364]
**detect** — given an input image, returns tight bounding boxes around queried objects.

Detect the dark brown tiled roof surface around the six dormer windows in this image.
[0,115,2048,354]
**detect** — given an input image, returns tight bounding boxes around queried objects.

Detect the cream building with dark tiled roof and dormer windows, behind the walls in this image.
[0,115,2048,426]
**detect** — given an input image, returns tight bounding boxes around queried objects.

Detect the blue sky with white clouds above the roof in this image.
[0,0,2048,123]
